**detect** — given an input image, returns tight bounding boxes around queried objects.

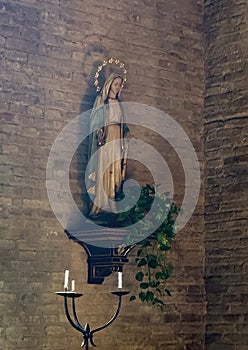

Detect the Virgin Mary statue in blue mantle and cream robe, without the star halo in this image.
[86,73,129,218]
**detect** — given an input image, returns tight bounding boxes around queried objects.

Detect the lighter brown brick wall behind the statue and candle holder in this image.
[0,0,205,350]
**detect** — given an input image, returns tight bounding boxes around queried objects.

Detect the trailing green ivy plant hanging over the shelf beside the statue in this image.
[117,184,180,308]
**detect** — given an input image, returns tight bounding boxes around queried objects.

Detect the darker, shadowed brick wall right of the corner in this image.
[204,0,248,350]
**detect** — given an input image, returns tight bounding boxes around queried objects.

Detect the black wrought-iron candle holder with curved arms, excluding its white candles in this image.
[56,291,129,350]
